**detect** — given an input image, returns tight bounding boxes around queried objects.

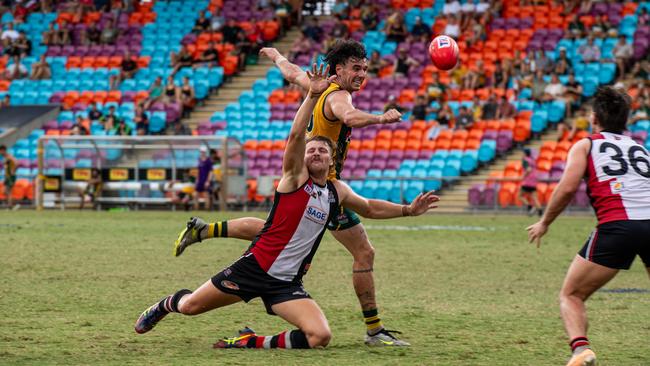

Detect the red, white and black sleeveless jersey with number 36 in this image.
[585,132,650,224]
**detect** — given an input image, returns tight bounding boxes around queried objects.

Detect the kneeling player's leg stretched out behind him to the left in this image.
[135,280,241,334]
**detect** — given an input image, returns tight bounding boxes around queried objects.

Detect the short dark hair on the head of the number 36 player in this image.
[593,86,632,133]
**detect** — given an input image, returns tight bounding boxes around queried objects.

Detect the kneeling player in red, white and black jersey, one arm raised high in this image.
[135,65,438,348]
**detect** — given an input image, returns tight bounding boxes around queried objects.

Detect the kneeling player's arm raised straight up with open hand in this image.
[278,64,330,190]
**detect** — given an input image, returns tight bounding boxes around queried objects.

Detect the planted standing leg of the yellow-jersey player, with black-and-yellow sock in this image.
[332,223,410,346]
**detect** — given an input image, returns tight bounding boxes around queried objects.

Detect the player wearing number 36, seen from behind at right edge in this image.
[527,87,650,366]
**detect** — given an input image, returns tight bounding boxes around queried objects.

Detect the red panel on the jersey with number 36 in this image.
[587,134,628,224]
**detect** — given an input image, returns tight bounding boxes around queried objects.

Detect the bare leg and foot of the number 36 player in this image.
[560,255,618,366]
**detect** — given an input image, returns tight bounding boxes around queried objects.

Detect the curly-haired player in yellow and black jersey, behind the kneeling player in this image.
[175,40,409,346]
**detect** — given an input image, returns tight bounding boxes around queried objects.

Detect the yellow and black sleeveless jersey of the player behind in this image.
[307,83,352,179]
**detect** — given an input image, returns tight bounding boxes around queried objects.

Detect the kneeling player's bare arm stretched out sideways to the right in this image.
[334,181,440,219]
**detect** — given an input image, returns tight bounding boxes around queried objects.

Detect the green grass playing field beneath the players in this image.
[0,211,650,366]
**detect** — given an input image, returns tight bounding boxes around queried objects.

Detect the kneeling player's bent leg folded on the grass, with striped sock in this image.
[214,299,332,349]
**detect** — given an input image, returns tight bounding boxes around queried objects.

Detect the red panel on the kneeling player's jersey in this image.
[251,179,311,272]
